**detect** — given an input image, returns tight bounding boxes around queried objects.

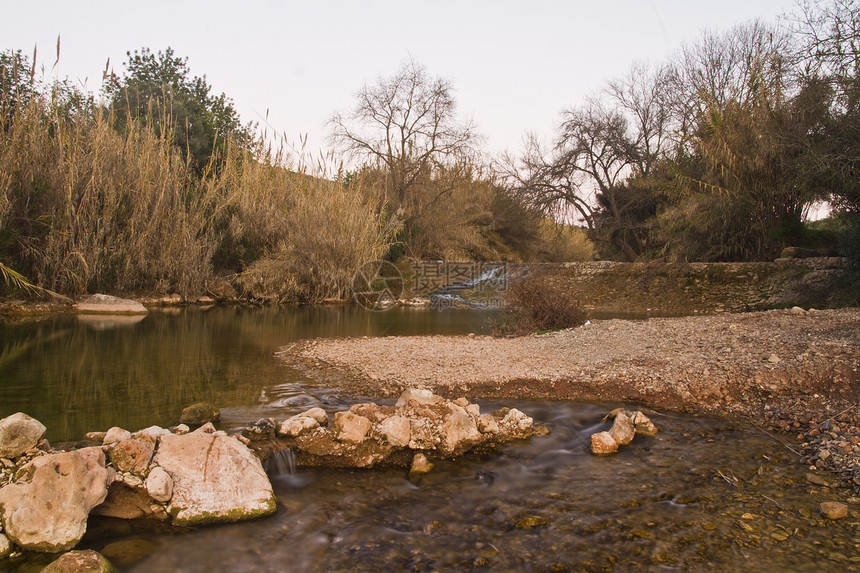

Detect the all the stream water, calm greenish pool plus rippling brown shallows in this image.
[0,306,860,572]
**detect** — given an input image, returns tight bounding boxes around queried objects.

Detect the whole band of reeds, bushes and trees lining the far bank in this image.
[0,0,860,302]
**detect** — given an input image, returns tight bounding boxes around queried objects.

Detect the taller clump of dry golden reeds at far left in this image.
[0,93,213,295]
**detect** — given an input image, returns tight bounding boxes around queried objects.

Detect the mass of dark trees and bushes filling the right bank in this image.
[505,0,860,261]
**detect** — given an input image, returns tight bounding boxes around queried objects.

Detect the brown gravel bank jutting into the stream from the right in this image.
[280,308,860,486]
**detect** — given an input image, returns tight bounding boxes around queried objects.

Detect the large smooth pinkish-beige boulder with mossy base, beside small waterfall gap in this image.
[155,432,276,525]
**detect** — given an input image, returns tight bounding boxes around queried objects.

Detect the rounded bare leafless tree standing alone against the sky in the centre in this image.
[329,60,479,208]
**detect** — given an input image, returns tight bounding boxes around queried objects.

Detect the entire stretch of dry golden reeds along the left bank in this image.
[0,87,390,302]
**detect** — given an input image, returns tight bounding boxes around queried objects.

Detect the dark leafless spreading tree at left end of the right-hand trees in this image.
[502,64,672,260]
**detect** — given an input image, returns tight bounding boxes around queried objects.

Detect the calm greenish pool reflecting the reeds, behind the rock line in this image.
[0,305,500,441]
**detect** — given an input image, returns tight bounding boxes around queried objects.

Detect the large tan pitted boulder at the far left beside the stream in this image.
[0,448,109,552]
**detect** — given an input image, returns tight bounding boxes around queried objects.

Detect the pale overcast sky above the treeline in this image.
[0,0,794,158]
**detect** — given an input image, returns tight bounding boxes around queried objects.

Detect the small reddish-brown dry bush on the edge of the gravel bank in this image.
[493,269,588,336]
